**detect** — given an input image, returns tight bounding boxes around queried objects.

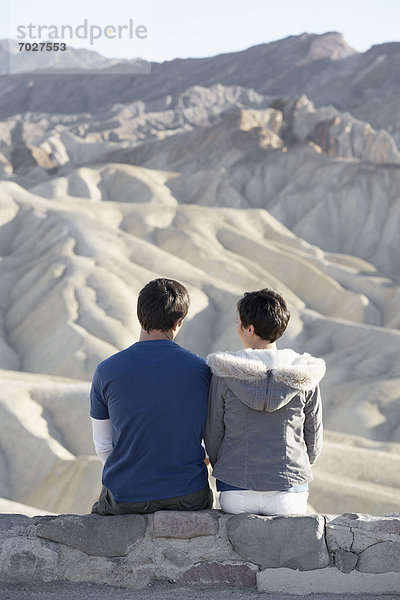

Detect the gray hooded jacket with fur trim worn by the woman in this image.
[204,349,325,491]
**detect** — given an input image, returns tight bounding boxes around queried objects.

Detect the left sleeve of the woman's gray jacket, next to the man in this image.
[204,375,226,466]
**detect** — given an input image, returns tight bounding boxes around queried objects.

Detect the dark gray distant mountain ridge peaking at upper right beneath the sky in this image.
[0,32,400,145]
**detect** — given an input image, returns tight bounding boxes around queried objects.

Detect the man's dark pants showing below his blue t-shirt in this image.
[92,484,213,515]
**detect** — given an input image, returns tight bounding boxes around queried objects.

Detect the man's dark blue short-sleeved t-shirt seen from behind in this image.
[90,340,211,502]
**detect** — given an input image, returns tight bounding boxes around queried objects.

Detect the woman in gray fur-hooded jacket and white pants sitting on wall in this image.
[204,289,325,515]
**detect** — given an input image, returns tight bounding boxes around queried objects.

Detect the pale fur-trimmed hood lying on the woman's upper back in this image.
[207,348,326,412]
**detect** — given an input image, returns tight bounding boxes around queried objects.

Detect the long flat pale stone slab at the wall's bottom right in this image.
[257,567,400,599]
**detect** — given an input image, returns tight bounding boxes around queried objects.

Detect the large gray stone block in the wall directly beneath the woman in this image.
[227,514,329,570]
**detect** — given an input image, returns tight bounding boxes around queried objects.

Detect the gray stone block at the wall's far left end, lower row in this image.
[0,537,58,581]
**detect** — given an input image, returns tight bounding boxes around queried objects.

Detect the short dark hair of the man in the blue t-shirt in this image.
[137,279,190,333]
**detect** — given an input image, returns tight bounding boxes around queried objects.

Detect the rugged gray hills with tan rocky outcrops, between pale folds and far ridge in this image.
[0,96,400,281]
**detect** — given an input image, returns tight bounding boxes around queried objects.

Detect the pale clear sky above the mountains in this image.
[0,0,400,62]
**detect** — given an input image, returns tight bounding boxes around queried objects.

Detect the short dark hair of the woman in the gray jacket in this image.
[237,288,290,343]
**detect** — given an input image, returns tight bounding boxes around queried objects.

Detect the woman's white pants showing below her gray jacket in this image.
[219,490,308,515]
